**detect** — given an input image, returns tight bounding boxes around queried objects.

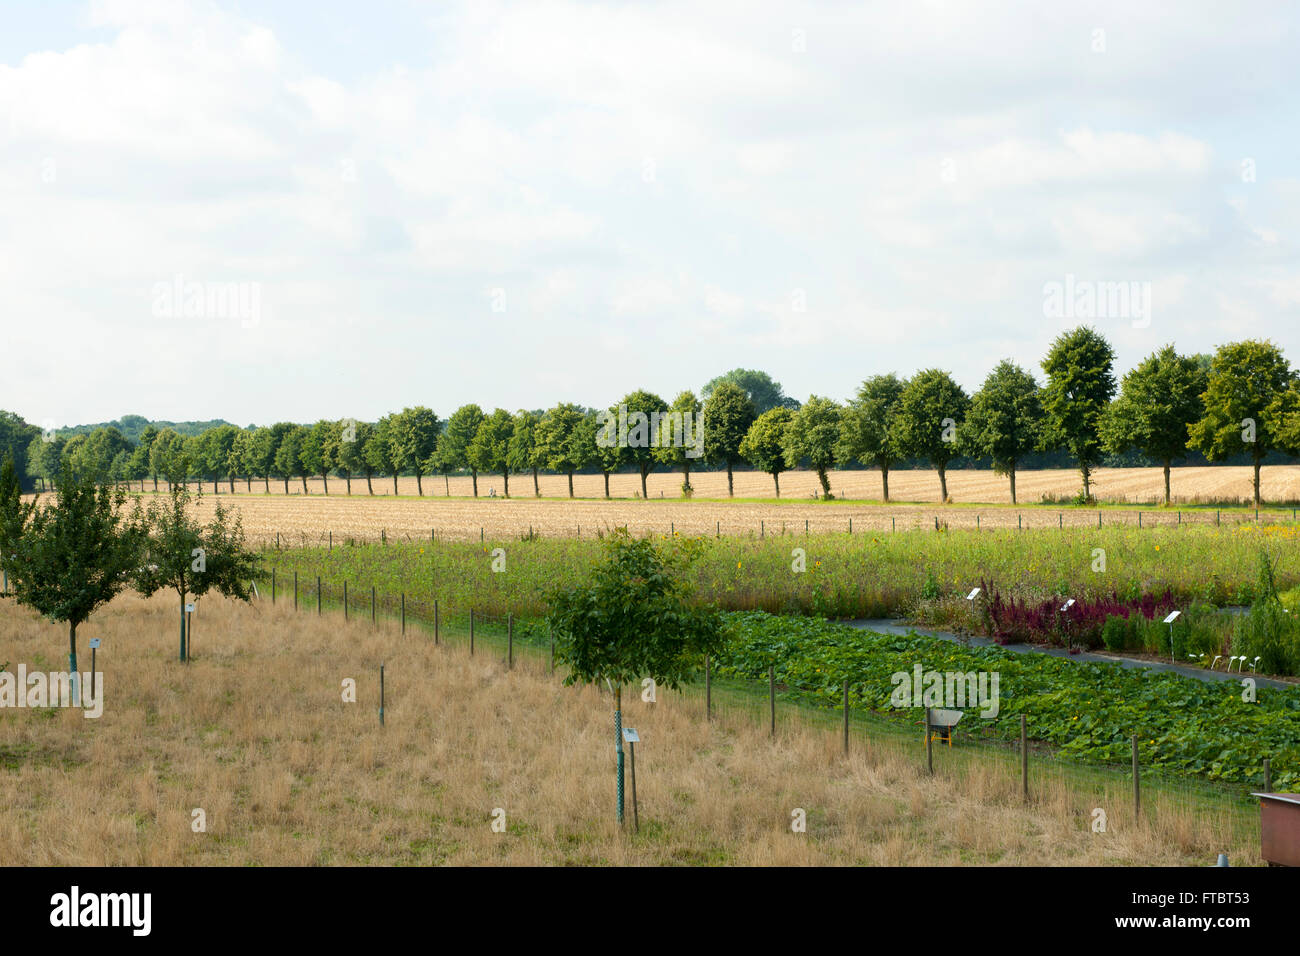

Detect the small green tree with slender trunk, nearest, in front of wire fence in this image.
[547,528,723,822]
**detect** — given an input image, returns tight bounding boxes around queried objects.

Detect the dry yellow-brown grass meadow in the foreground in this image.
[0,597,1258,865]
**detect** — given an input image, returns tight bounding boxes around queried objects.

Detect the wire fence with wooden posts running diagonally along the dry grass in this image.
[259,575,1271,845]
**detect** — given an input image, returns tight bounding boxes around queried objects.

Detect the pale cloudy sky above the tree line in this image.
[0,0,1300,427]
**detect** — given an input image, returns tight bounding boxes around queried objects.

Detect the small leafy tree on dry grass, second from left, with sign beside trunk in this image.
[133,484,257,661]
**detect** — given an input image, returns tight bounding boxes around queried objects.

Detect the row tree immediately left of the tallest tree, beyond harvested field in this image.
[957,359,1043,505]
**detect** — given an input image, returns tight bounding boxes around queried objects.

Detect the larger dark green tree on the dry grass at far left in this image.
[0,459,143,697]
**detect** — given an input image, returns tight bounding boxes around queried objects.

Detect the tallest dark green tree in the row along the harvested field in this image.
[1040,325,1115,501]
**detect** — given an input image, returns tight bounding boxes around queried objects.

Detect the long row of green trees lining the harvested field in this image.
[15,338,1300,503]
